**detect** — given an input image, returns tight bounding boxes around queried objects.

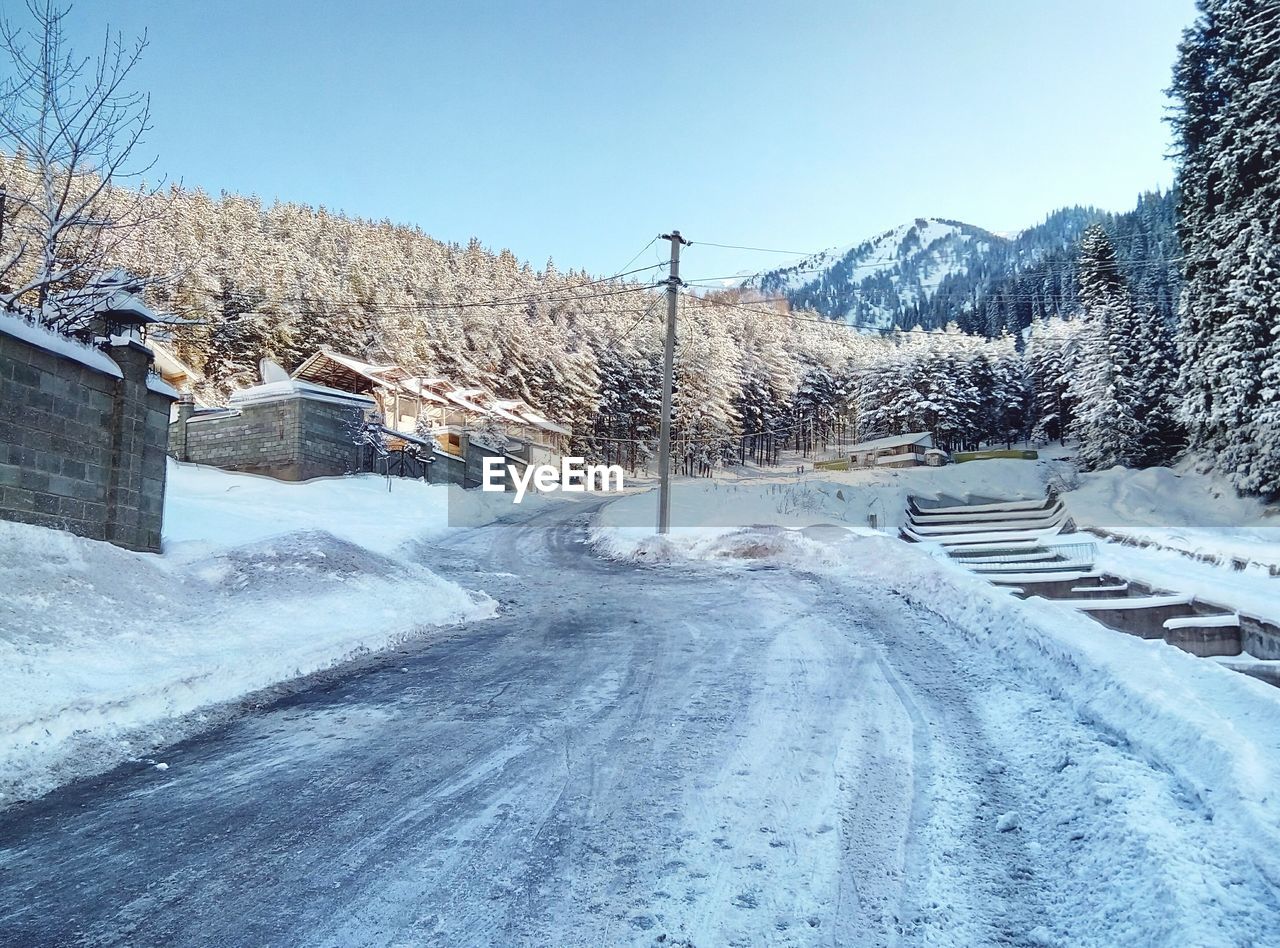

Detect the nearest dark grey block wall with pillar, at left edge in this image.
[0,324,173,551]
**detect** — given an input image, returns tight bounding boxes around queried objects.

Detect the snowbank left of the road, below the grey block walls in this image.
[0,464,494,806]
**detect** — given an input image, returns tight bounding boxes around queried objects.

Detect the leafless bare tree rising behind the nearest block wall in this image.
[0,0,172,331]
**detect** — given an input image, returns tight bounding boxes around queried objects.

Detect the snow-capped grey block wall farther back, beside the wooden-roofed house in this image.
[169,383,374,481]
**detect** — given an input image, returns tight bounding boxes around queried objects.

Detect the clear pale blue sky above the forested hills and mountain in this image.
[62,0,1194,276]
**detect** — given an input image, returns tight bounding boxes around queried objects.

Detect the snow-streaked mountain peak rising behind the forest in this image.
[742,217,1007,329]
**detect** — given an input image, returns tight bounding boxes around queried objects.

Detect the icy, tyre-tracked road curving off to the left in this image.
[0,505,1280,945]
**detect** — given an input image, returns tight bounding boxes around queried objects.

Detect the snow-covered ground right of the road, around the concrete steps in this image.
[594,462,1280,944]
